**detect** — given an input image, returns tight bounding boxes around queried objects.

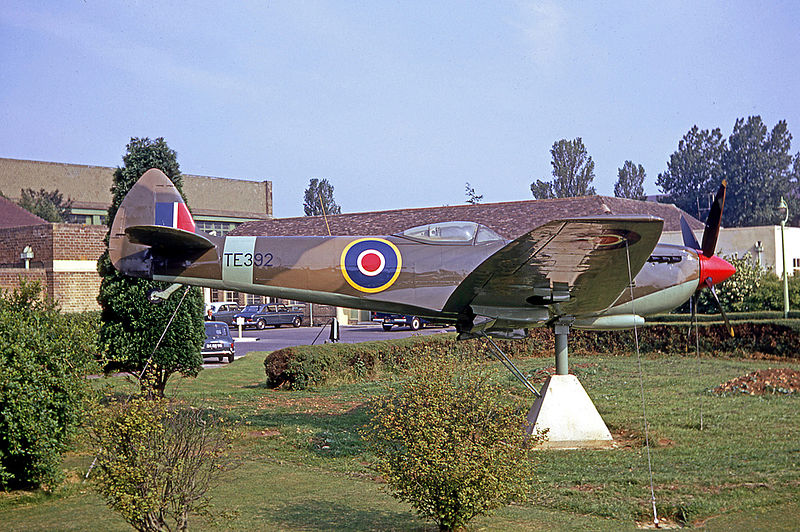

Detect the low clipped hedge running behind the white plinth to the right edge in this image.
[264,320,800,389]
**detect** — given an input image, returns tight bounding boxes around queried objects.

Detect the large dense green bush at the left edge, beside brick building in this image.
[0,281,97,489]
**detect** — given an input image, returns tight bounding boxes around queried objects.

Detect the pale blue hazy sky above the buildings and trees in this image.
[0,0,800,217]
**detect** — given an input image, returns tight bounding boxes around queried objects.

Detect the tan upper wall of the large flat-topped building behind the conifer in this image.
[0,157,272,219]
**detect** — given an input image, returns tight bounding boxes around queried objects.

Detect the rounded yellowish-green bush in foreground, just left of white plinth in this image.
[363,353,535,530]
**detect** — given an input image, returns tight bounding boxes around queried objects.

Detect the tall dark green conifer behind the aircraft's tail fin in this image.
[98,138,205,393]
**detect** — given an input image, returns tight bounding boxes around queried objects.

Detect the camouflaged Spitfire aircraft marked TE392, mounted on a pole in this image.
[109,169,735,338]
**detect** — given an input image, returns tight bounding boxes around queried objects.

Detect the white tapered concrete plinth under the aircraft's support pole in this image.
[528,375,614,449]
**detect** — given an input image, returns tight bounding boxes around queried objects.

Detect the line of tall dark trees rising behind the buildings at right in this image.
[531,116,800,227]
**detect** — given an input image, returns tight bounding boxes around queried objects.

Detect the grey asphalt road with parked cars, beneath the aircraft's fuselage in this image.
[203,323,455,368]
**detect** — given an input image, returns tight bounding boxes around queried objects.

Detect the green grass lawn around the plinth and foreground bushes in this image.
[0,353,800,530]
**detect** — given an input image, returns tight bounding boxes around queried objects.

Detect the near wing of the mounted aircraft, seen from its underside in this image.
[448,216,664,319]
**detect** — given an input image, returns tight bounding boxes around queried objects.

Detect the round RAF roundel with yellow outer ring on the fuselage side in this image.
[341,238,403,293]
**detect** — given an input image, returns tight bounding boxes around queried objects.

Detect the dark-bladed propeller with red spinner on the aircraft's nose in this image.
[681,179,736,336]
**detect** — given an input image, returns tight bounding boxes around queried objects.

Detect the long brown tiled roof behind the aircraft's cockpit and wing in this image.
[229,196,704,239]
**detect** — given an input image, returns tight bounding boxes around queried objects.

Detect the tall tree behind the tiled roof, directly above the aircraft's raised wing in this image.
[531,137,596,199]
